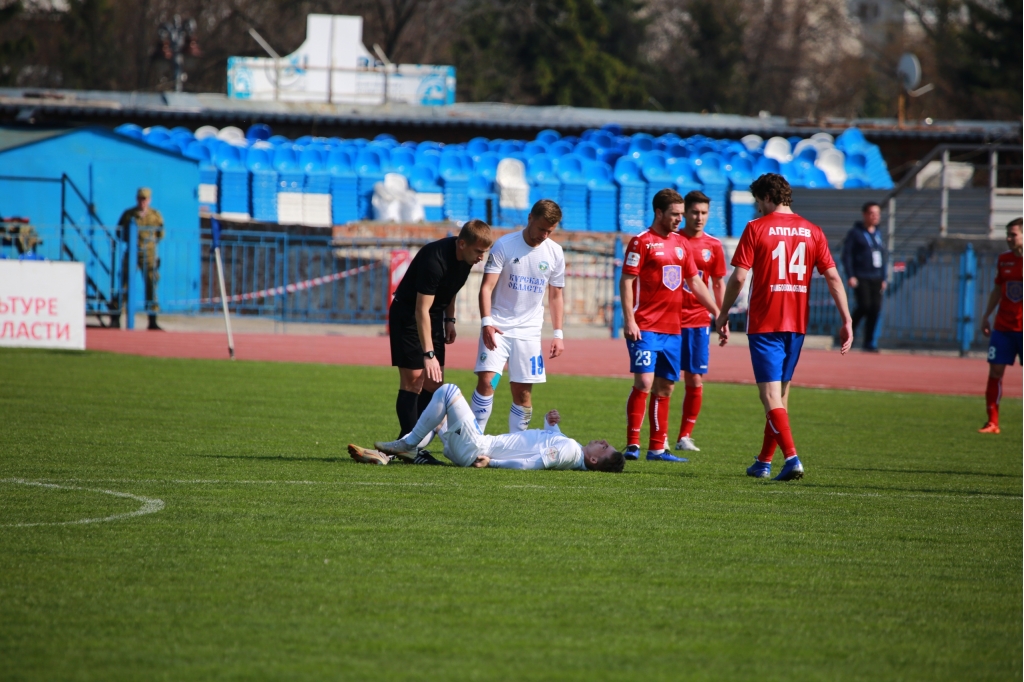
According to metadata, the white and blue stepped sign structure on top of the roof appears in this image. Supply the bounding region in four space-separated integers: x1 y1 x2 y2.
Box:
234 14 455 105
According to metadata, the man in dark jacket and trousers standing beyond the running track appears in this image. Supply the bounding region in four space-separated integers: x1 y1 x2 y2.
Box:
843 202 888 352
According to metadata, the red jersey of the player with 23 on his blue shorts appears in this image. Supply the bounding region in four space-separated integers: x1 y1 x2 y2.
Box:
623 229 697 334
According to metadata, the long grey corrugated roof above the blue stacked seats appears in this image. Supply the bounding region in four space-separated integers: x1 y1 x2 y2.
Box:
0 88 1021 142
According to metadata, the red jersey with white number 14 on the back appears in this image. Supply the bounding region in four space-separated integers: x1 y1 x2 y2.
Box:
732 212 836 334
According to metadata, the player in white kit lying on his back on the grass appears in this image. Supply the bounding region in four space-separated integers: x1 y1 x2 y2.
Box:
348 384 625 472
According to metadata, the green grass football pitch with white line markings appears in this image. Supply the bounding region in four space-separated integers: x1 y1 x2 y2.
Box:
0 348 1022 682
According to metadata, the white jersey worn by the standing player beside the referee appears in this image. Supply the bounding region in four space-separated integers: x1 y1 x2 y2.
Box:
483 231 565 339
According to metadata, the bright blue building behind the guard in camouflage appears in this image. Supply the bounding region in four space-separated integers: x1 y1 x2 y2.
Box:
0 127 201 313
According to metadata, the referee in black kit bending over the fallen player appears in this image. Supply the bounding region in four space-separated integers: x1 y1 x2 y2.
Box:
388 220 494 464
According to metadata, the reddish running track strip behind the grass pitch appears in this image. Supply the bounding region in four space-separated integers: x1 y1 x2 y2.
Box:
86 328 1024 398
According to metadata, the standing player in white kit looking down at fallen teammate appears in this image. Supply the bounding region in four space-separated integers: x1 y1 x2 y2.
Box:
471 199 565 433
